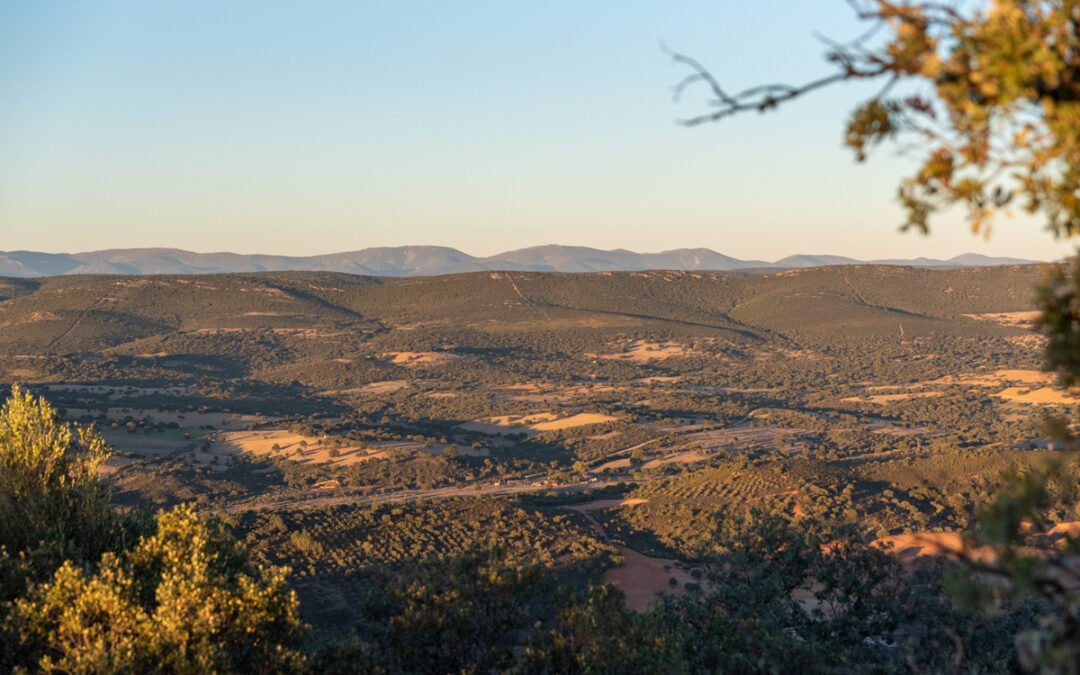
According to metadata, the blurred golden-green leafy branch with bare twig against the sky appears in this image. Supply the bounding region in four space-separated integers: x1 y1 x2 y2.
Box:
672 0 1080 237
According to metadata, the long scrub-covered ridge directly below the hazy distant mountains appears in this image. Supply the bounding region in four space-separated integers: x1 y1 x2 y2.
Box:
0 266 1039 354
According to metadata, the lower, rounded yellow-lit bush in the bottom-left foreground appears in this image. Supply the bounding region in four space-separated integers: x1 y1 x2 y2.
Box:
13 505 305 673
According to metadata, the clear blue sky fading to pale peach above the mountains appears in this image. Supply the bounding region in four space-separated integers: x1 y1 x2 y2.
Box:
0 0 1071 259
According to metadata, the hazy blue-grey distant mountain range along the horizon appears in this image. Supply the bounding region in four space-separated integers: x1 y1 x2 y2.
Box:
0 245 1037 276
